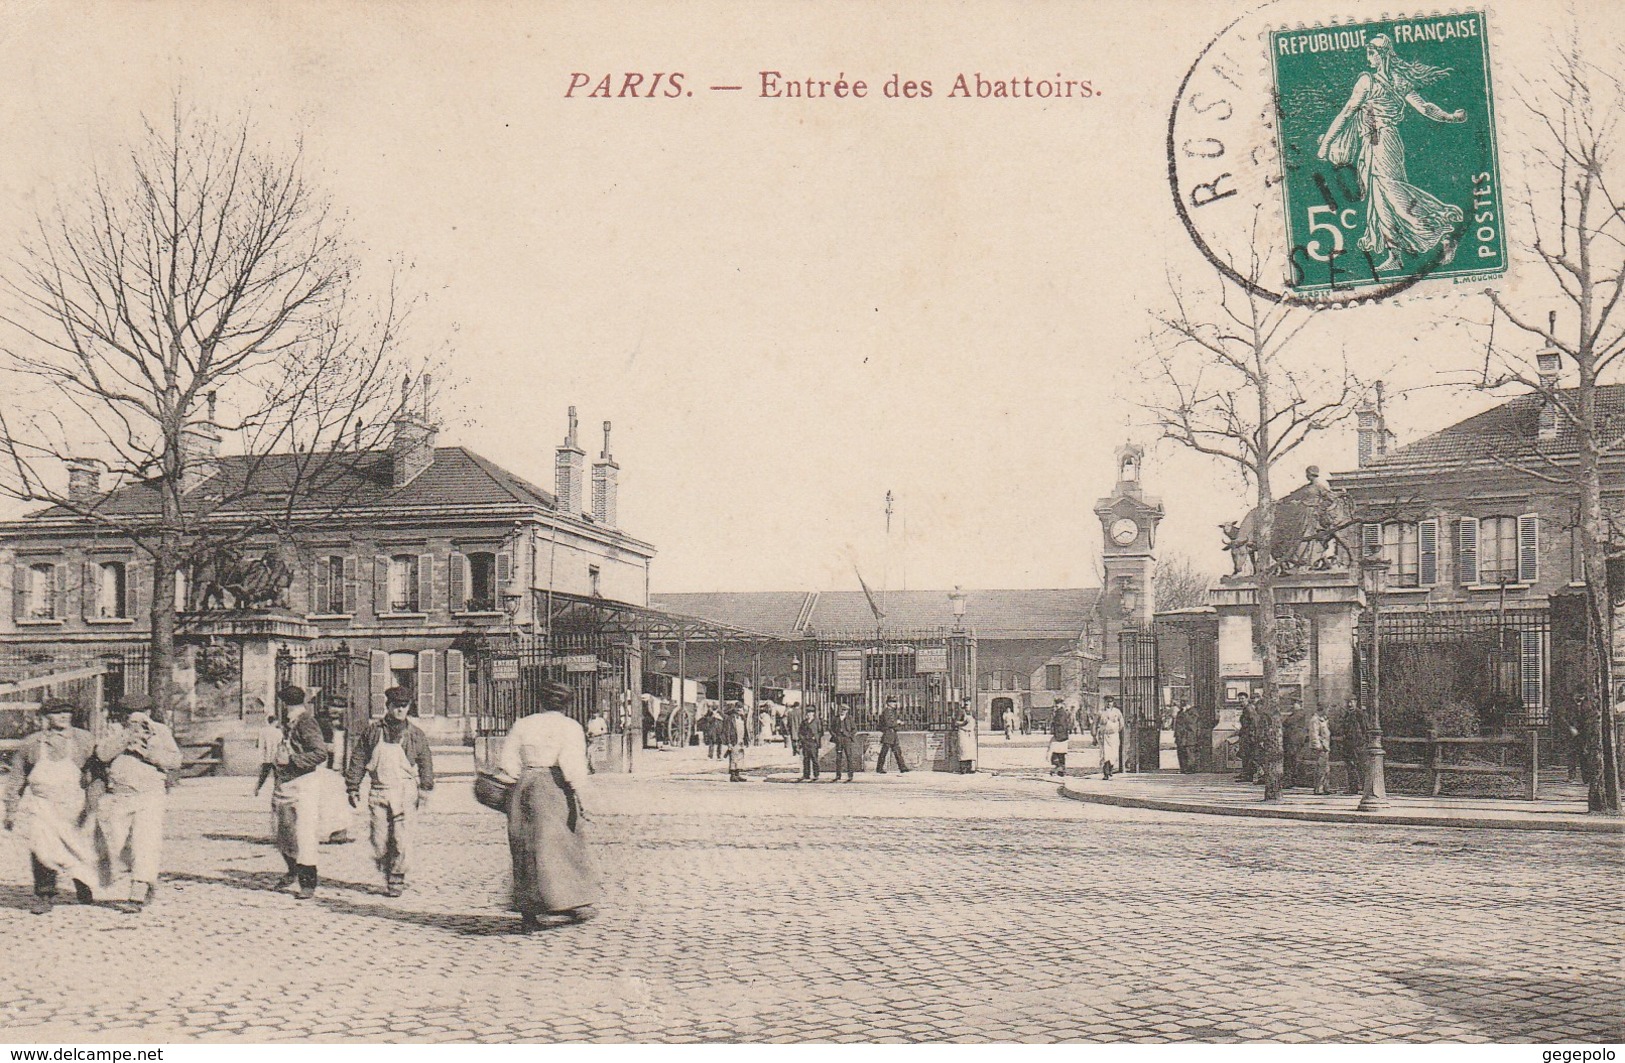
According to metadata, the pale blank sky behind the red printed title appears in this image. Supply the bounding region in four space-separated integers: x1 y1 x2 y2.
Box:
0 0 1625 592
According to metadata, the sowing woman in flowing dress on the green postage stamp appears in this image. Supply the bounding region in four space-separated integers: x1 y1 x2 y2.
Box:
1316 34 1467 270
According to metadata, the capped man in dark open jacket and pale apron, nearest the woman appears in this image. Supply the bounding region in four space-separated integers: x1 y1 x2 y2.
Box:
345 686 434 897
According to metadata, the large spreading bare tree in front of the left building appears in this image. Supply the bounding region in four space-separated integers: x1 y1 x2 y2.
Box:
0 101 425 715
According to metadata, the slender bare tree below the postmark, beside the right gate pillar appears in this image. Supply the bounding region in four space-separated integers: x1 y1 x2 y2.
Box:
1141 254 1360 801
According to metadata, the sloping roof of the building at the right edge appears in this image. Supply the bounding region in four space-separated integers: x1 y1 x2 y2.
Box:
1341 384 1625 476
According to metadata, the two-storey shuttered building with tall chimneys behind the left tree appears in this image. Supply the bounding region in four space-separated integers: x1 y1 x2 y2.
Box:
0 394 655 741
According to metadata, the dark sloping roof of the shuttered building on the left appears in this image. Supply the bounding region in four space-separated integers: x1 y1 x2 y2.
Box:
29 447 557 518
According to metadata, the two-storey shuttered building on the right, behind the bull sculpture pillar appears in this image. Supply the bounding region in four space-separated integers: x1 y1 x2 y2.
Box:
1333 378 1625 737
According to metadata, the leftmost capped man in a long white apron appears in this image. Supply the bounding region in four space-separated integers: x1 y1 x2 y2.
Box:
5 701 96 915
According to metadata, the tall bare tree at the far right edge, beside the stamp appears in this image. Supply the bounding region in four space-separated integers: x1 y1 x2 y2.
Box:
1477 33 1625 813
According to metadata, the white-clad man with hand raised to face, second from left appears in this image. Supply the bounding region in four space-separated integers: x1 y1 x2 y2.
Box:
96 694 182 912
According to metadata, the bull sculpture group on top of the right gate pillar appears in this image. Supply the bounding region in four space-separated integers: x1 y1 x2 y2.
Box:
1219 465 1355 577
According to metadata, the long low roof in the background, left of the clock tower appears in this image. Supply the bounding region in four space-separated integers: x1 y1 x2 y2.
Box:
650 587 1100 639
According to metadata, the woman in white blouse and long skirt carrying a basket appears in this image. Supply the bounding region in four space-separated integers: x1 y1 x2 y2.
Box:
499 681 598 930
